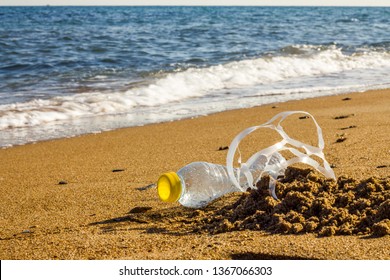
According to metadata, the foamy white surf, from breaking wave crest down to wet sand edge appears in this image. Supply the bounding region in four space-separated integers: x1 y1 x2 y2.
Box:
0 45 390 146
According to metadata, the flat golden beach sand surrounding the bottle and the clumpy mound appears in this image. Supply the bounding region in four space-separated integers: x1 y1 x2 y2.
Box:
0 90 390 259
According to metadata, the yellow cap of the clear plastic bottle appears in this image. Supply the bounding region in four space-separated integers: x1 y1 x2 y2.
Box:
157 172 182 202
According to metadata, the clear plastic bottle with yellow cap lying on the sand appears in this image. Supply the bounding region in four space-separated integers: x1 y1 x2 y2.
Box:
157 153 285 208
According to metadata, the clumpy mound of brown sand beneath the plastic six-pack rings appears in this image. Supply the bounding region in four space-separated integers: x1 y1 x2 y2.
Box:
202 167 390 236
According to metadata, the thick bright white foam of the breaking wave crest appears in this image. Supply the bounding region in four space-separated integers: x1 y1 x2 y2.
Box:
0 46 390 130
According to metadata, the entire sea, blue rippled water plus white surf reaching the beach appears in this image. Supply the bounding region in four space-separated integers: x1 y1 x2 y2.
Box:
0 7 390 147
